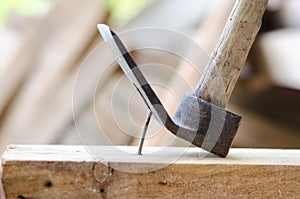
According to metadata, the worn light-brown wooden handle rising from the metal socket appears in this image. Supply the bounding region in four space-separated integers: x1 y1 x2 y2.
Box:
194 0 268 108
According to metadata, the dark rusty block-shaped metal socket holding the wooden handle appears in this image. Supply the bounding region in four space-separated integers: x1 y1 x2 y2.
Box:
173 95 241 157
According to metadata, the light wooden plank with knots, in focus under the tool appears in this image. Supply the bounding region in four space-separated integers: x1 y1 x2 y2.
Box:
2 145 300 198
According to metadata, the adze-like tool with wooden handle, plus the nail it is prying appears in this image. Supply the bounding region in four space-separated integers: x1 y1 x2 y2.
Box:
97 0 268 157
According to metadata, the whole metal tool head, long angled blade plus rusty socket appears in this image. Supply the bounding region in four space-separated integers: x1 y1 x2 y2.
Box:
98 24 241 157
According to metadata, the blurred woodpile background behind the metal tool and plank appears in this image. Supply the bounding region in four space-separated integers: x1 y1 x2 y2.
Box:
0 0 300 151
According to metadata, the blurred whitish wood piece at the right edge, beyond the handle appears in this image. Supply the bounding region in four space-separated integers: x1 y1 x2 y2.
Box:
258 28 300 90
